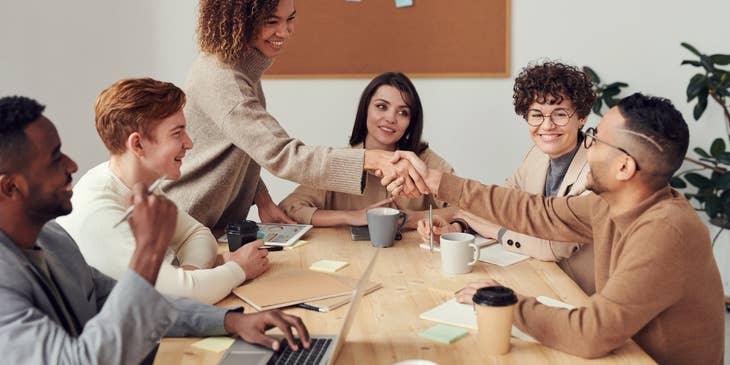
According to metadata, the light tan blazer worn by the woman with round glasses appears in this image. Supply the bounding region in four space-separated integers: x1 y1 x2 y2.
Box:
502 146 596 295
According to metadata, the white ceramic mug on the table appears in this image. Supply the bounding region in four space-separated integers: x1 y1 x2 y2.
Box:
439 232 479 274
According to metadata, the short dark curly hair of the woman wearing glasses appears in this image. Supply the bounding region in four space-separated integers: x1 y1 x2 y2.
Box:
512 61 596 119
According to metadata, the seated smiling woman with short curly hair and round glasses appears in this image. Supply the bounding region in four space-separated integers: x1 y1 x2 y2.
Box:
418 62 596 295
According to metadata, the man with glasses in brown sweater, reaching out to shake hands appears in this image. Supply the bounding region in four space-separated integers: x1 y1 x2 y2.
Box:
389 94 725 365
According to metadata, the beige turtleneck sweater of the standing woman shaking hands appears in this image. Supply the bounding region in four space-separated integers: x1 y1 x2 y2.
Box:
165 48 364 228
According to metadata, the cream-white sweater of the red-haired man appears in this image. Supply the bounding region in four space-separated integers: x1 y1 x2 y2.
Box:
57 162 246 304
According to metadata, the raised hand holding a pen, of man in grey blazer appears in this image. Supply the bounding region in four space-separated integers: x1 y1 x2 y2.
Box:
129 183 177 285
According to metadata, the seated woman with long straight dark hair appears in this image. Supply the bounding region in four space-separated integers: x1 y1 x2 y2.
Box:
279 72 454 228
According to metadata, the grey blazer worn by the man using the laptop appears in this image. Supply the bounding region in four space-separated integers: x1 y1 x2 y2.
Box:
0 222 235 364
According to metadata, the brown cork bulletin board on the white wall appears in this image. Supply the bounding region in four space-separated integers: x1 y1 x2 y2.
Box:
266 0 510 78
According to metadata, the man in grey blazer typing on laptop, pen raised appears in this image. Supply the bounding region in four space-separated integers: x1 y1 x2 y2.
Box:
0 97 309 364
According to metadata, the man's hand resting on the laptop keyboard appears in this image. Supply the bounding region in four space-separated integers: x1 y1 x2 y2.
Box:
224 310 309 351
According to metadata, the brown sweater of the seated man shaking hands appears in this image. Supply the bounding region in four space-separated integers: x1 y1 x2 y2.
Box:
438 174 725 365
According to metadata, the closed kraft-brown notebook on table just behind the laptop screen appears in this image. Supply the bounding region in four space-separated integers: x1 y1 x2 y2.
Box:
233 270 354 311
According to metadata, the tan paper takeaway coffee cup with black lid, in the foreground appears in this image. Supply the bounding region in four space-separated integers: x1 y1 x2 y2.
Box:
472 286 517 355
